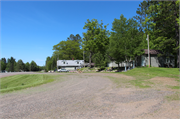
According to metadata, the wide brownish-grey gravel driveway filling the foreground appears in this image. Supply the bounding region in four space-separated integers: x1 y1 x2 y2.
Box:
0 73 180 119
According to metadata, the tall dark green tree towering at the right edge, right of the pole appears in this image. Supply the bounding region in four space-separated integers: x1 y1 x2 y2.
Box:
145 1 180 67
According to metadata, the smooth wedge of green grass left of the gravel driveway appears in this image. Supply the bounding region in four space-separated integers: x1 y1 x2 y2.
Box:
0 74 56 93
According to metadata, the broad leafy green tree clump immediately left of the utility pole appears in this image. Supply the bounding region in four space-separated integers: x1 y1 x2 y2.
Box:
108 15 144 67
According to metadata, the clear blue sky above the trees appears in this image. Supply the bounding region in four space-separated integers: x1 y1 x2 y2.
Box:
0 1 141 66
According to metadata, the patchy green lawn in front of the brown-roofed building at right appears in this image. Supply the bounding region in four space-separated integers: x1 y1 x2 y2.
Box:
111 67 180 89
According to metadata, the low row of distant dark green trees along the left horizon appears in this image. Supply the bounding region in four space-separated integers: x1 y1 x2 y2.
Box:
0 57 45 72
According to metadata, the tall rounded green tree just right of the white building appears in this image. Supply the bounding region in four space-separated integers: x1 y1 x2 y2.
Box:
83 19 109 67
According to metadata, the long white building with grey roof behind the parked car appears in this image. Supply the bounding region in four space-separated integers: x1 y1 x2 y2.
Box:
57 60 84 70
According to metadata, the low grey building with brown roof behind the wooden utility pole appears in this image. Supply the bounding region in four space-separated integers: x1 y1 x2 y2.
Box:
135 49 175 67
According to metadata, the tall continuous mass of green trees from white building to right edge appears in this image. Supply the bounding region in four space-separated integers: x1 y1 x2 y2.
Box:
46 0 180 70
